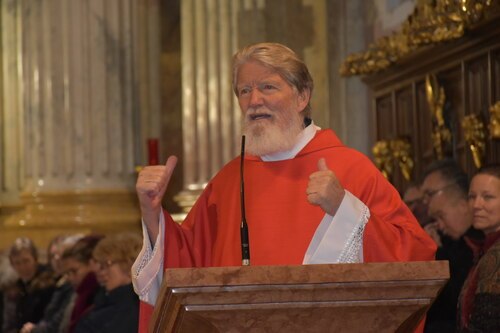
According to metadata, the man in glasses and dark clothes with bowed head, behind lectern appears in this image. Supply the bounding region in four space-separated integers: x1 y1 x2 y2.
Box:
422 160 481 333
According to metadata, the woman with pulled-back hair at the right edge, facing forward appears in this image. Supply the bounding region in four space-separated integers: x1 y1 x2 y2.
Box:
458 165 500 332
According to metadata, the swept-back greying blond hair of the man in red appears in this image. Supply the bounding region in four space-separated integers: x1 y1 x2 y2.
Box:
233 43 314 117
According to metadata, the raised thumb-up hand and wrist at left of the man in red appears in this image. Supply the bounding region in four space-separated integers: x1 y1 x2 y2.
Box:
135 156 177 244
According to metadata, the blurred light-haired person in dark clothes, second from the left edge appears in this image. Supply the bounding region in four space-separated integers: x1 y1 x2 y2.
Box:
9 237 55 330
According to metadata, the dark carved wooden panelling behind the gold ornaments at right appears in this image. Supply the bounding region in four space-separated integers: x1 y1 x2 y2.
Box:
364 18 500 191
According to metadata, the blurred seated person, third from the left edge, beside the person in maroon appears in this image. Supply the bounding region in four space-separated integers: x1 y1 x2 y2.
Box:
20 235 83 333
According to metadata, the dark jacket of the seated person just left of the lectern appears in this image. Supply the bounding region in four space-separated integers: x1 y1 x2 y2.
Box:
75 284 139 333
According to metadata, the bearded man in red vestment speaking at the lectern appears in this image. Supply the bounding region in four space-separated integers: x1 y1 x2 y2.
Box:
133 43 435 328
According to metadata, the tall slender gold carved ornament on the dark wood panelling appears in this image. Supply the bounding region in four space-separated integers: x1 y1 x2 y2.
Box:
425 74 451 160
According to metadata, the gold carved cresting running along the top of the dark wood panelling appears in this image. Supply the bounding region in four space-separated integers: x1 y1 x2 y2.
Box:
340 0 500 76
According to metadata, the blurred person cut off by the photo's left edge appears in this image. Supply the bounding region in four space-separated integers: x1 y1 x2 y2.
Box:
0 249 19 333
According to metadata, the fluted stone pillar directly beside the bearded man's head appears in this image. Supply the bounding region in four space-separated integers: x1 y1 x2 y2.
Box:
176 0 241 211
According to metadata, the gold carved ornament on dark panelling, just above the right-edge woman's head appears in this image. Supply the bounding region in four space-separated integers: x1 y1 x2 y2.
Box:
462 114 486 168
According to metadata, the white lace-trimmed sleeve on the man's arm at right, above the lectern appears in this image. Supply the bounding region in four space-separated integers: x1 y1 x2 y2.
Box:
303 191 370 264
